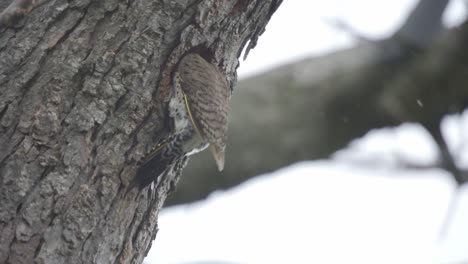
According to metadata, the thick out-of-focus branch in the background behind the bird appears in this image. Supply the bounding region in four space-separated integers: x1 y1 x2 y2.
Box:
165 0 468 205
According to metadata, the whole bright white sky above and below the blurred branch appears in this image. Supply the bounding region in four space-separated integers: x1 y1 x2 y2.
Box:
145 0 468 264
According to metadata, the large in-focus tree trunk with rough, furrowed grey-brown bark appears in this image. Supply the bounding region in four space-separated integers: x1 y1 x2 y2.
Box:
0 0 281 263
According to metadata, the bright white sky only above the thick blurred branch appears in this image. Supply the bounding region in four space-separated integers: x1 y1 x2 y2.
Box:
238 0 466 78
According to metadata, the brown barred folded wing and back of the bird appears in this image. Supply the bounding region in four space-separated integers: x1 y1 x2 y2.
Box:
178 53 230 170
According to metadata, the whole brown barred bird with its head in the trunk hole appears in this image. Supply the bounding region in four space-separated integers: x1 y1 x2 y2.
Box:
132 53 231 190
